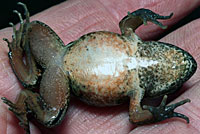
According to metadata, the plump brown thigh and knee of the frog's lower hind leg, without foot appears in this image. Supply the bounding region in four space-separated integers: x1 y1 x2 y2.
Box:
33 65 70 127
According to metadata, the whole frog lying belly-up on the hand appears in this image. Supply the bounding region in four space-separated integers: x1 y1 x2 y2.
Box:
2 2 197 134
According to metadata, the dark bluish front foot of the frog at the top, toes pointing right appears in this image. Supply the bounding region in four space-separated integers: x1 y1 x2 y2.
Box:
128 8 173 29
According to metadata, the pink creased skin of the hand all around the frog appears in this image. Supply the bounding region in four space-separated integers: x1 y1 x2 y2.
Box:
0 0 200 134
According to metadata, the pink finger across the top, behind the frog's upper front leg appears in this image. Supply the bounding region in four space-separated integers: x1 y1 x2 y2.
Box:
26 0 200 44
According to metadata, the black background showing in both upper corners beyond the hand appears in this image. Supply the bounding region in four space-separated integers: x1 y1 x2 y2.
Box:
0 0 200 30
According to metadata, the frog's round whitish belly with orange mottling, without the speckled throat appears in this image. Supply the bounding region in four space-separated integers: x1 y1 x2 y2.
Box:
64 32 139 106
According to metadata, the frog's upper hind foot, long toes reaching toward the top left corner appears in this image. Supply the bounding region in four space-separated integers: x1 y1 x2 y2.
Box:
4 2 40 87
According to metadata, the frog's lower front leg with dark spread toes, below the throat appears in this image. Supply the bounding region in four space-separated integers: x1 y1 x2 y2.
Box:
129 89 190 124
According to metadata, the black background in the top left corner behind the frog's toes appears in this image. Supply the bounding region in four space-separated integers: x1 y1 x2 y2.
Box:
0 0 66 29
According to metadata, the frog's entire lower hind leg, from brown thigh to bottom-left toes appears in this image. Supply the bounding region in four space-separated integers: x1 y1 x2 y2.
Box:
2 66 70 134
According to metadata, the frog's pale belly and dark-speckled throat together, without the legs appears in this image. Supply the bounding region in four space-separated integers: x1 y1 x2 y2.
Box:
63 31 195 106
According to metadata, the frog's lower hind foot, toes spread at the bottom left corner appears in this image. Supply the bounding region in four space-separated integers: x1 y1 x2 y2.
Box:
1 97 30 134
